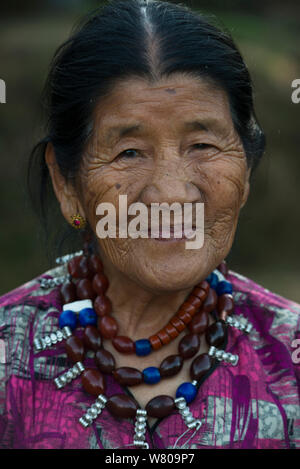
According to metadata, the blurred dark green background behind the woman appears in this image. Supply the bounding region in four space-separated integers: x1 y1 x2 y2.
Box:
0 0 300 302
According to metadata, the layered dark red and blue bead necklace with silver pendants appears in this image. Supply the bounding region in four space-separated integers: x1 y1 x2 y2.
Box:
34 249 251 449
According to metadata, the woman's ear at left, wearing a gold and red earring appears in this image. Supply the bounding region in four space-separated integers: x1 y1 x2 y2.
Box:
45 142 85 223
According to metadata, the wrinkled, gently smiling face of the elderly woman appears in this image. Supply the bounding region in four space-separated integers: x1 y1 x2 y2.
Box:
55 74 249 291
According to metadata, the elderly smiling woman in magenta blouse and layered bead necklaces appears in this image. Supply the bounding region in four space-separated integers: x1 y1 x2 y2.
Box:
0 0 300 449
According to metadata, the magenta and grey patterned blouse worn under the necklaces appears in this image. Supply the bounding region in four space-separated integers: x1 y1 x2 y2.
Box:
0 266 300 449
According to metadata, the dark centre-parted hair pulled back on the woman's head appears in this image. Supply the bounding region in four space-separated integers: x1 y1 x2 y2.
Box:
28 0 265 256
